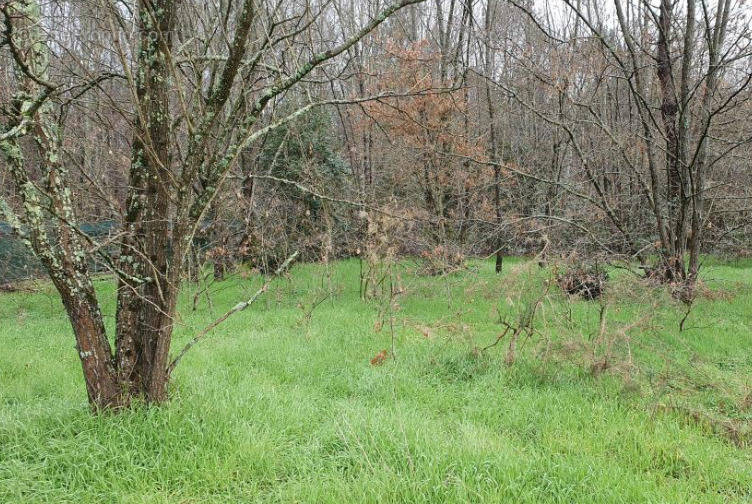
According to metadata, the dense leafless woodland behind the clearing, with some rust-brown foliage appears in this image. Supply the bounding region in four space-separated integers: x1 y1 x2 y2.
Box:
0 0 752 282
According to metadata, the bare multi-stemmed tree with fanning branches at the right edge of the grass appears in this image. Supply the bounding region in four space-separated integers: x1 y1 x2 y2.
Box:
488 0 752 286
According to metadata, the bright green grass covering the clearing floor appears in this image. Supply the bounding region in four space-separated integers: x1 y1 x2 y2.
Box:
0 260 752 504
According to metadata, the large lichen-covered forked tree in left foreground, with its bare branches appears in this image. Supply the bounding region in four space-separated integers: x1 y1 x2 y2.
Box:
0 0 420 409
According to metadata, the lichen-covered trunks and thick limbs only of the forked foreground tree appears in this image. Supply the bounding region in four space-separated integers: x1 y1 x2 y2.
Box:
0 0 423 410
